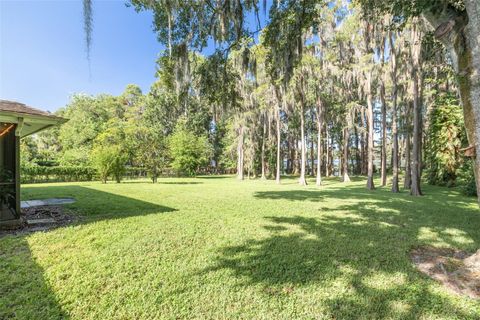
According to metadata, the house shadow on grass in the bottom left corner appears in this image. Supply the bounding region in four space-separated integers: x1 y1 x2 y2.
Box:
0 237 69 319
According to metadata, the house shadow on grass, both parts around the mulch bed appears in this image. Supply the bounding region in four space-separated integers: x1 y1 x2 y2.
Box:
0 185 175 319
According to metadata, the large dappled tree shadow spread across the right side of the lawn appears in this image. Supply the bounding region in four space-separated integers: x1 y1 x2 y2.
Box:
201 186 480 319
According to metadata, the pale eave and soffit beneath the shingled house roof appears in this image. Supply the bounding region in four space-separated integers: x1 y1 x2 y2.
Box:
0 110 68 138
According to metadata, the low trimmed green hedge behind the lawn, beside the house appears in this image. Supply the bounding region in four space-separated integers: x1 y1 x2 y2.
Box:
20 164 97 183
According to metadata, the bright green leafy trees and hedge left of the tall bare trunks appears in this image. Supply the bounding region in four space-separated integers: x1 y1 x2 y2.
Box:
21 85 219 183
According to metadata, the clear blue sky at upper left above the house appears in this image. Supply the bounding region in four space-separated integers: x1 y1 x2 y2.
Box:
0 0 164 112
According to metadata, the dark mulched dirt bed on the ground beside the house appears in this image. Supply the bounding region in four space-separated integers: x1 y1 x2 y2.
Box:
0 205 79 237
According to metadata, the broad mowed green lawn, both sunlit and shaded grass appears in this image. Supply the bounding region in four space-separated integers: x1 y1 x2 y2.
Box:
0 176 480 319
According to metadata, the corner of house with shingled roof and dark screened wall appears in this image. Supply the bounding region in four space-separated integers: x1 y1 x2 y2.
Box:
0 100 67 227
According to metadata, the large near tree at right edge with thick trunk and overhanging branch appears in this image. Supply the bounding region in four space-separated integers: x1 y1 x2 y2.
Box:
357 0 480 201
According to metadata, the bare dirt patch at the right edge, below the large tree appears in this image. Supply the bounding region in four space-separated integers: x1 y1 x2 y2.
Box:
411 246 480 299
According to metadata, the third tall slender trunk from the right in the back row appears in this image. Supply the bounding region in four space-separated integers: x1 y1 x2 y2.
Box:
390 33 400 193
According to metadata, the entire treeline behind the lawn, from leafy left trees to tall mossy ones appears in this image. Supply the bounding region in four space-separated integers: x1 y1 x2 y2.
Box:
23 2 476 195
